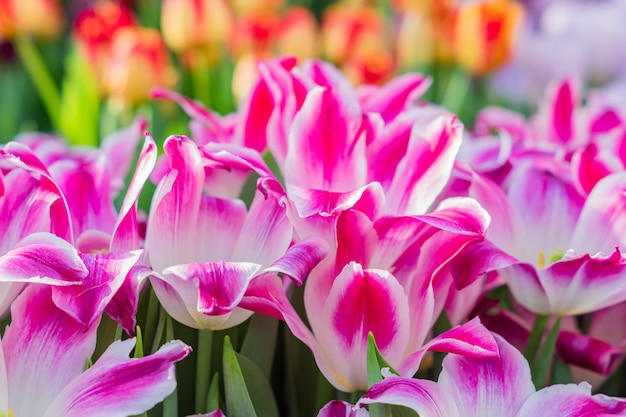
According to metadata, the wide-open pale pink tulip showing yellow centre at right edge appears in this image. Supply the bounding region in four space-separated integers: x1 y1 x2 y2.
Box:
470 164 626 315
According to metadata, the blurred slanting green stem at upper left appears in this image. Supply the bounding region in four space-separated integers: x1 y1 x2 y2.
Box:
14 35 61 129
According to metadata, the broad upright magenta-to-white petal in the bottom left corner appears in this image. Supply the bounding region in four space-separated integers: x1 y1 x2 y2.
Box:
2 285 98 416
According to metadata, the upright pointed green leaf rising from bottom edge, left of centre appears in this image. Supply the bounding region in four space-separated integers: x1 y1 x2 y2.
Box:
222 336 257 417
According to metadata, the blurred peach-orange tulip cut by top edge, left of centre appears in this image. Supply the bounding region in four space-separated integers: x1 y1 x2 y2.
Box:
161 0 234 52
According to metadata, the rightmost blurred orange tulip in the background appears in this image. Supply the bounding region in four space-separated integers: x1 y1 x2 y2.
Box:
454 0 523 75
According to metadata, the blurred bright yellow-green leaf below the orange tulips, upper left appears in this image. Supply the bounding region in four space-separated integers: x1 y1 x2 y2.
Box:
59 48 100 146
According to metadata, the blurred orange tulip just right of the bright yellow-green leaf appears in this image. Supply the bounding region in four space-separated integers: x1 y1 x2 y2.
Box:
104 27 176 104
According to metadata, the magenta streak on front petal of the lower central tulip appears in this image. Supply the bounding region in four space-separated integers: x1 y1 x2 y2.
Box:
333 268 398 350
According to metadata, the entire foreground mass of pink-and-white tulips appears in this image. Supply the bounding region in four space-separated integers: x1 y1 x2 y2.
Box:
0 54 626 416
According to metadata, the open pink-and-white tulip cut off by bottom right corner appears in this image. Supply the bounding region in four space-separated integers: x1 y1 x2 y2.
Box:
354 335 626 417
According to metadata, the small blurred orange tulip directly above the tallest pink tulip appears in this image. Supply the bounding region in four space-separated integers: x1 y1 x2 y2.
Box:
274 7 318 60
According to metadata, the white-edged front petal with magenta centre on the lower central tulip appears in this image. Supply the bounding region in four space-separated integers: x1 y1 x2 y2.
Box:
316 262 410 392
